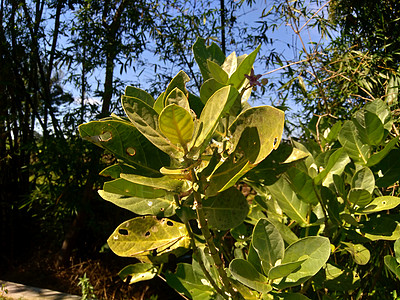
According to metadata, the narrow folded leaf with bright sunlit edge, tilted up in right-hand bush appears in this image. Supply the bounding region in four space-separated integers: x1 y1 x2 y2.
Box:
314 148 350 186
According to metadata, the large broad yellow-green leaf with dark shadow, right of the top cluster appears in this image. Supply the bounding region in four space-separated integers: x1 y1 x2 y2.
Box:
229 106 285 164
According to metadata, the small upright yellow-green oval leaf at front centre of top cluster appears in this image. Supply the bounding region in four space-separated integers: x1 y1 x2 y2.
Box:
159 104 194 148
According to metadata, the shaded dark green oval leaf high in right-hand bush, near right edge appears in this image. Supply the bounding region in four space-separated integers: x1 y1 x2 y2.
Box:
353 109 384 146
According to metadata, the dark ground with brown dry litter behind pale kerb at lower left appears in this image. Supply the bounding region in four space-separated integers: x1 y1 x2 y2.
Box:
0 253 183 300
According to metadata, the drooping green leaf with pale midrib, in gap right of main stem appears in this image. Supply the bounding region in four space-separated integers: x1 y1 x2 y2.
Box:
267 177 309 226
